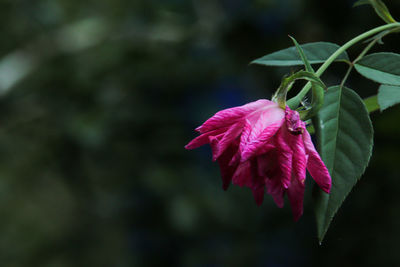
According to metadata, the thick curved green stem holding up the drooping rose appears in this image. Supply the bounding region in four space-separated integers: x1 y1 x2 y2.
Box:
288 23 400 107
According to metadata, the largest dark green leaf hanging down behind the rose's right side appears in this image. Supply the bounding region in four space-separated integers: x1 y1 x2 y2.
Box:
313 86 373 242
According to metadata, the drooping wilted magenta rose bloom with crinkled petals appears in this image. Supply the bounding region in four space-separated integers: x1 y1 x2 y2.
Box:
185 99 331 220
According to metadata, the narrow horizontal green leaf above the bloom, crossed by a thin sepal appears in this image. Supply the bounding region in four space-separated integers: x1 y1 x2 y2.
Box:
250 42 349 66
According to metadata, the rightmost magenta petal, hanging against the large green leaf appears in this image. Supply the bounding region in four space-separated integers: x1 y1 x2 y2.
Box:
302 131 332 193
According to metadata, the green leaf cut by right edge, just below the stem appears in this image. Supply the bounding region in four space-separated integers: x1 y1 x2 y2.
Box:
354 52 400 85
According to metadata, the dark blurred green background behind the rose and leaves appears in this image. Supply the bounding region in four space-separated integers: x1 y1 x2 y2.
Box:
0 0 400 267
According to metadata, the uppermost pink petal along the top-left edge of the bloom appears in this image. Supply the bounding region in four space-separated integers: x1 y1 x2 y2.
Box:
196 99 275 133
